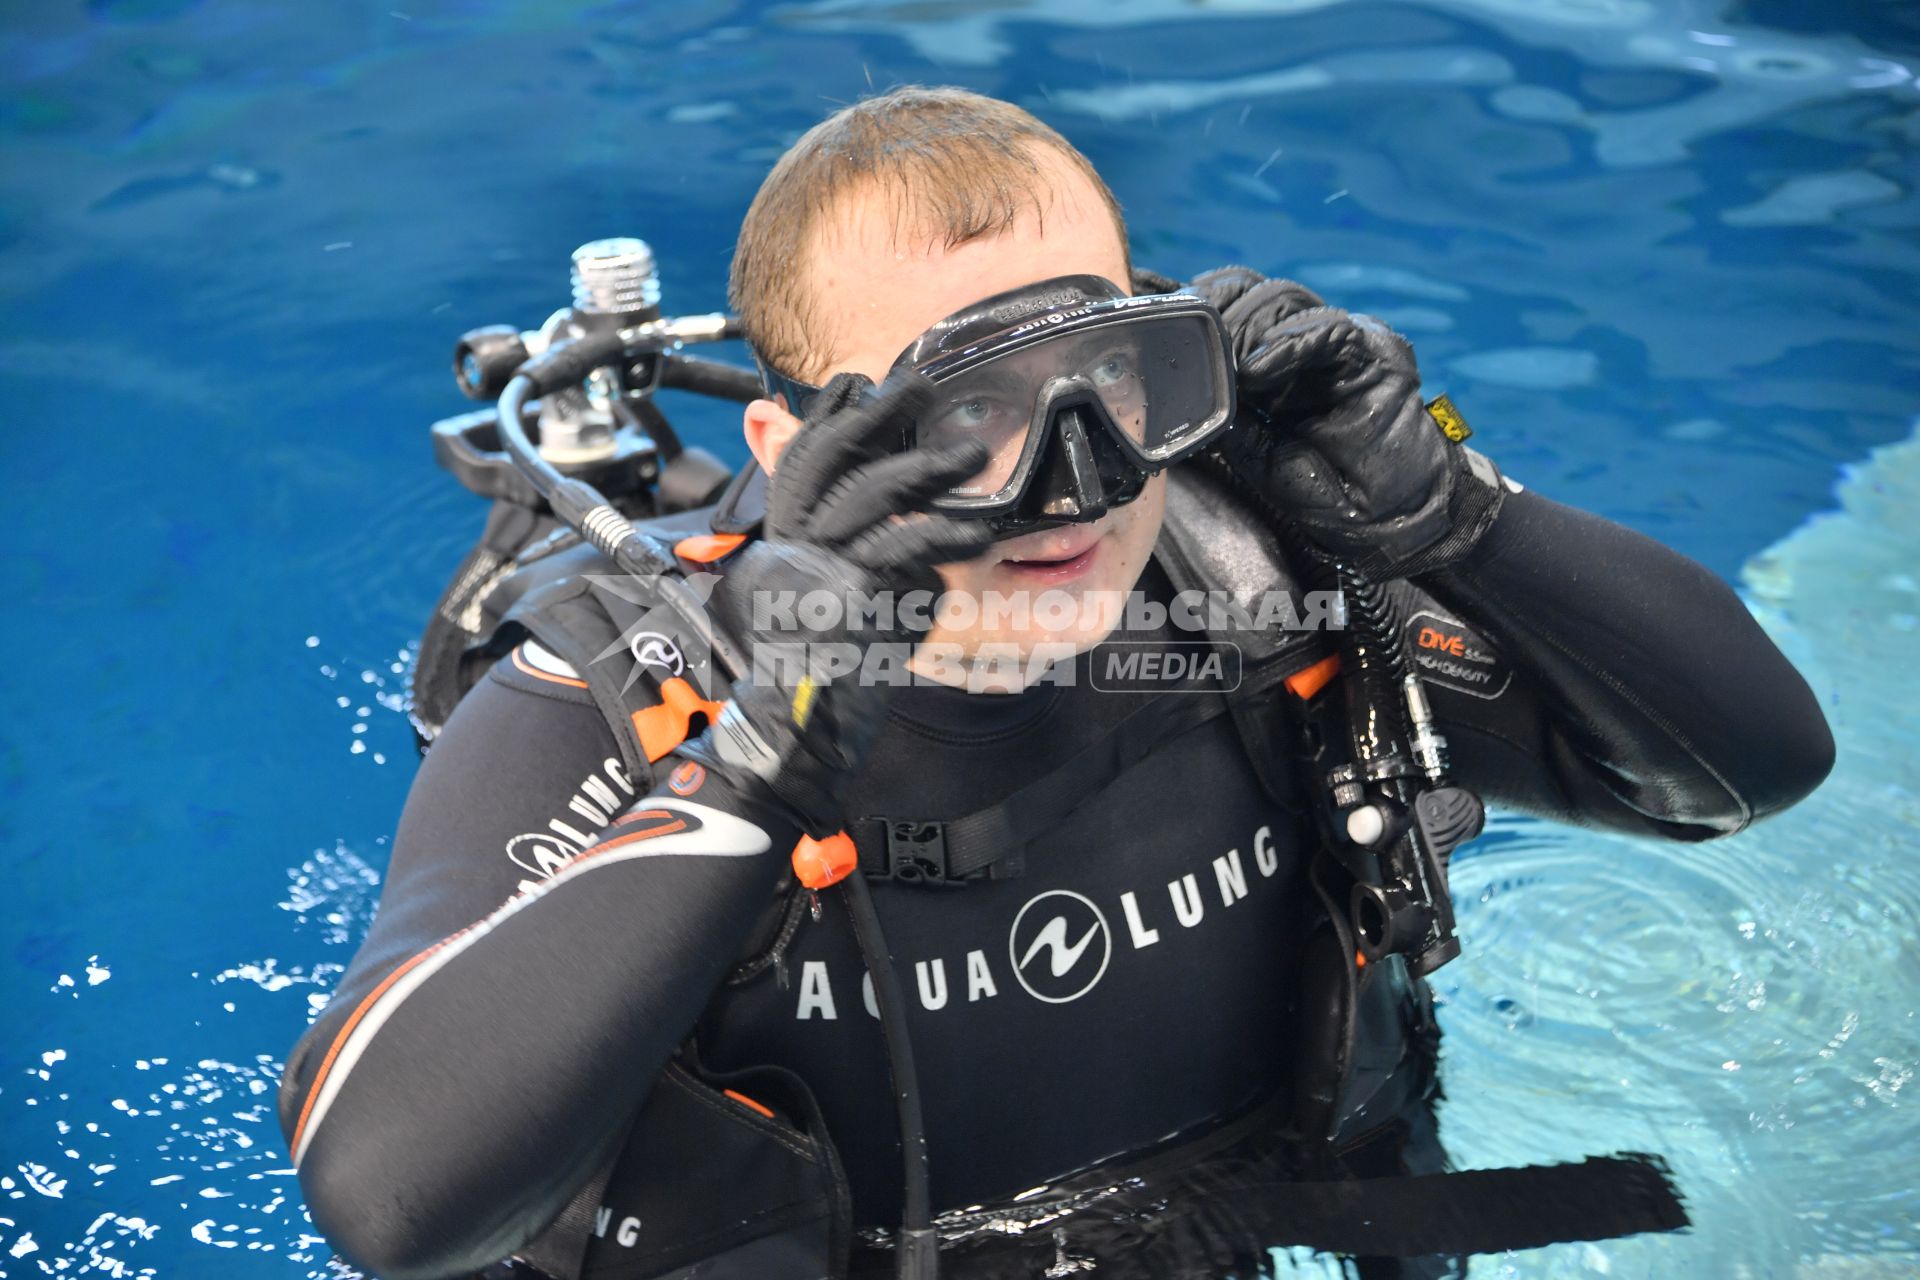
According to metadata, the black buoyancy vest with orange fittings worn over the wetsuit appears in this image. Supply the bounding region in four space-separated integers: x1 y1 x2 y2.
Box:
413 466 1678 1280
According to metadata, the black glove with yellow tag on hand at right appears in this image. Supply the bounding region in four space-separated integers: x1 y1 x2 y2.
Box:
1190 267 1505 581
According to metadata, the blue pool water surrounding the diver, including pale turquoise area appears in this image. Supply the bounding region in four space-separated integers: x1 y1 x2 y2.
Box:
0 0 1920 1280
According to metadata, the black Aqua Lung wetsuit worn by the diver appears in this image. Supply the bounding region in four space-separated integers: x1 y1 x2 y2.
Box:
280 493 1832 1276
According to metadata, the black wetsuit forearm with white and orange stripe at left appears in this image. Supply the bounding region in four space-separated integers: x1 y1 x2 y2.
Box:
280 762 797 1280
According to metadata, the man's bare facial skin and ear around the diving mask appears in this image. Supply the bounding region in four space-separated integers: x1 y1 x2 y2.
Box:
747 154 1165 687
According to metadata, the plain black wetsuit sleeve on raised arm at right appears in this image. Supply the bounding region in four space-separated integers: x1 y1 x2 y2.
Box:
1409 491 1834 841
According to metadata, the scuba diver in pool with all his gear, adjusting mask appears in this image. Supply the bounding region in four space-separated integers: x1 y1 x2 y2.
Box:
280 86 1834 1280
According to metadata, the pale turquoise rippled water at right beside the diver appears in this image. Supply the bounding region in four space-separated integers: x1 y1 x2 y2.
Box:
1436 427 1920 1276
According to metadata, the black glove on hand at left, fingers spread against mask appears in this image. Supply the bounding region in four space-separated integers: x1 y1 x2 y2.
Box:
710 374 993 837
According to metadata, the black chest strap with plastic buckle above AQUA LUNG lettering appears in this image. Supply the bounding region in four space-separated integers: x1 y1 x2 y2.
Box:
847 689 1227 883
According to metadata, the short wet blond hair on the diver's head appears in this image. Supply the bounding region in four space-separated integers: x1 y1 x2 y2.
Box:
728 84 1133 382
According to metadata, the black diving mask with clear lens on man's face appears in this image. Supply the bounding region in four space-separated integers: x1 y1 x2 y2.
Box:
760 276 1235 535
